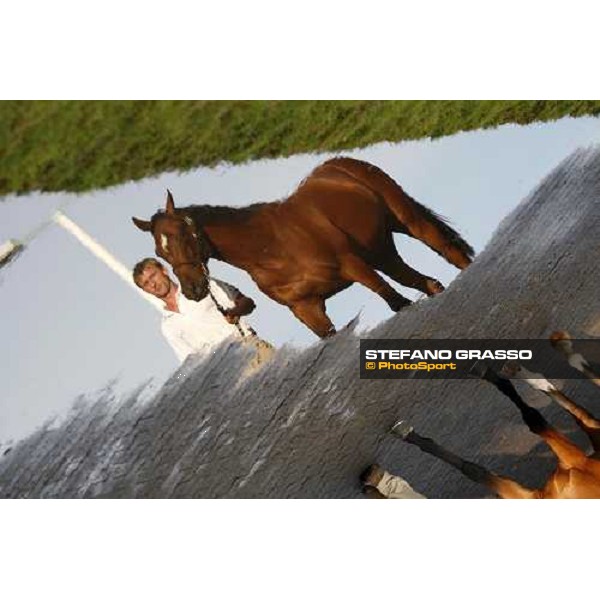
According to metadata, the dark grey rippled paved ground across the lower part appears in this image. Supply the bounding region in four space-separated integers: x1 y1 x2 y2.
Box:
0 150 600 498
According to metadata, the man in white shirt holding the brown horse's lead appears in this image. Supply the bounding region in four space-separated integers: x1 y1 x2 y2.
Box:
133 258 273 366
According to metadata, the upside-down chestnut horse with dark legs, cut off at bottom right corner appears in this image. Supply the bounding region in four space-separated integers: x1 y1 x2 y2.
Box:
392 332 600 498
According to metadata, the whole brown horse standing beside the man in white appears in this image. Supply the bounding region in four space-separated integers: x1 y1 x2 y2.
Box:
133 157 473 337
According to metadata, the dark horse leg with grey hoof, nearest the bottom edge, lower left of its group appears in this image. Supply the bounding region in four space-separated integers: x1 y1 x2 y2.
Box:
392 421 536 499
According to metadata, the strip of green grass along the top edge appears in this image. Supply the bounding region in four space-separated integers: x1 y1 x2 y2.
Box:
0 100 600 195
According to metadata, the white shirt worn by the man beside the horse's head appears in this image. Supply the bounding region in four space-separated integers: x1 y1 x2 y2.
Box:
161 279 252 362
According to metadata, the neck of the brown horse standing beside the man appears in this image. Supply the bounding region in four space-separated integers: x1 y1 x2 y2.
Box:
185 205 271 268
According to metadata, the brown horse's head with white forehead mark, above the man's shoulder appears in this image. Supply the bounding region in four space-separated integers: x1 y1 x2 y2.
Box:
132 190 210 301
